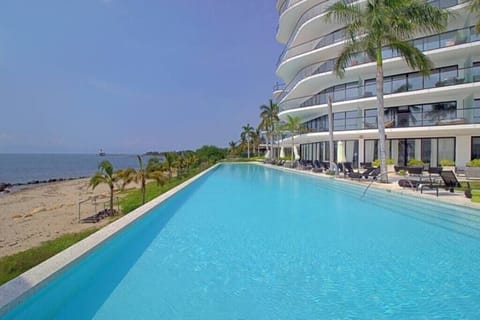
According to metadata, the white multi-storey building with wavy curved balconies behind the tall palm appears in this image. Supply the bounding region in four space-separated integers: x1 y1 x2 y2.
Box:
274 0 480 166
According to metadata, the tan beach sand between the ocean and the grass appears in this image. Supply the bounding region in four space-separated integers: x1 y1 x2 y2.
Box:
0 179 131 257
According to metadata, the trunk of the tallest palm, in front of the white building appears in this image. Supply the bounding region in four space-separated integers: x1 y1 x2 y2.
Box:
376 51 388 182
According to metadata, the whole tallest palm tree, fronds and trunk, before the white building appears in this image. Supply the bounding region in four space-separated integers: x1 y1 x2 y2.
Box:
327 0 448 182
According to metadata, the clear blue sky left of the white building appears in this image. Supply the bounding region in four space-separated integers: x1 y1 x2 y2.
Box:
0 0 282 153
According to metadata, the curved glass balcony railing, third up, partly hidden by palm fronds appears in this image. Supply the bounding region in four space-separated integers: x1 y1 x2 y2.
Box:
279 27 480 105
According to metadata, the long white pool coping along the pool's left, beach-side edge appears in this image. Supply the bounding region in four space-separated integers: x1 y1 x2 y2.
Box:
0 164 220 317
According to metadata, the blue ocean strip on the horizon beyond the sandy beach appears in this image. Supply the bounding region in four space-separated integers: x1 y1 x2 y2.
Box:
0 153 156 184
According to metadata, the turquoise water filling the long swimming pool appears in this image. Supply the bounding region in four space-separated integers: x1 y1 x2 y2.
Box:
3 164 480 319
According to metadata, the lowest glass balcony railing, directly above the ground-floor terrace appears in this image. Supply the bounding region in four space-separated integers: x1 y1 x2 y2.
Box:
307 107 480 132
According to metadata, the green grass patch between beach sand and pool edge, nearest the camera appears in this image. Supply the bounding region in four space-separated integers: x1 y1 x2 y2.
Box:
0 228 98 284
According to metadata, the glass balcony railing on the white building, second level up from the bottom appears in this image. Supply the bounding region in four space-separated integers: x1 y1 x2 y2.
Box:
280 64 480 111
